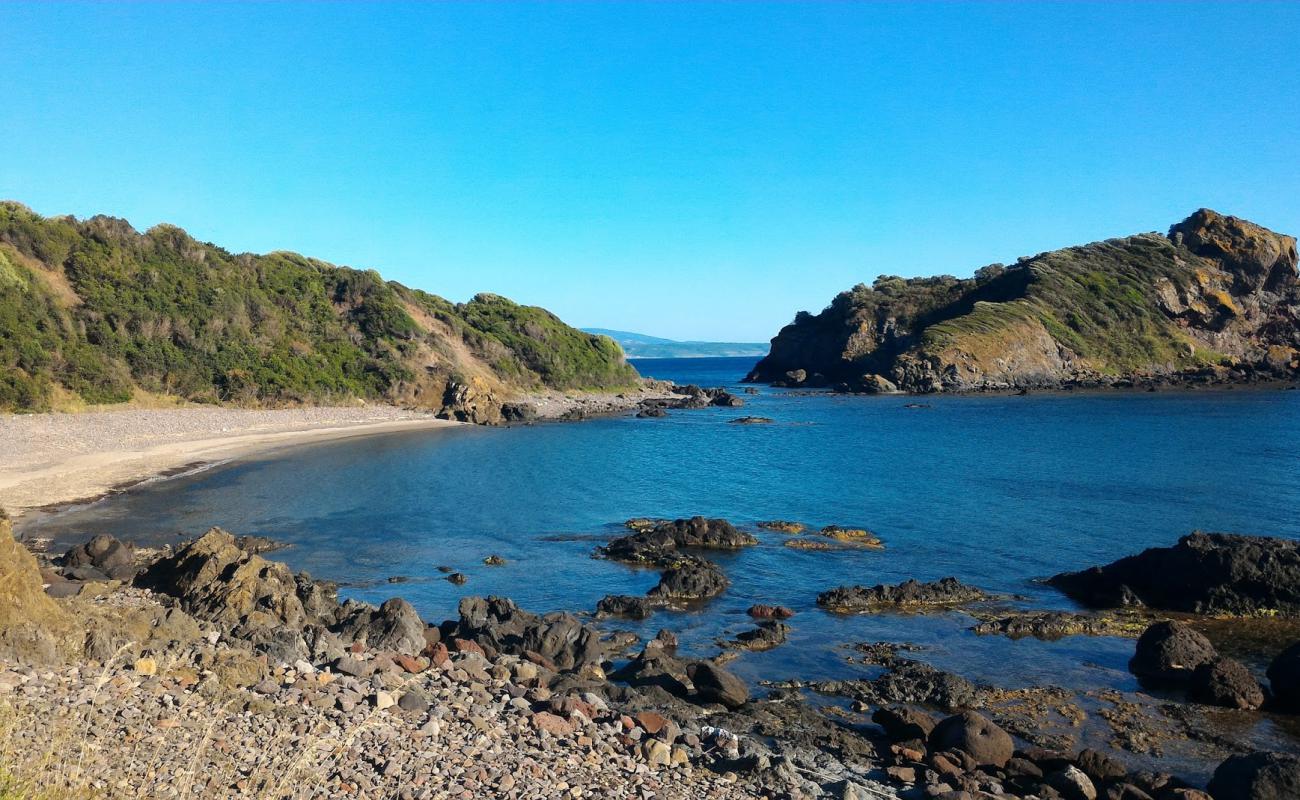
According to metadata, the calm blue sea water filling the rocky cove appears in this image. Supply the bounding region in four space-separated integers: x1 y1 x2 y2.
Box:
23 359 1300 780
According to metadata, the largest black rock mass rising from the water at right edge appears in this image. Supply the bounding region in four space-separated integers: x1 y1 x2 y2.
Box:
1048 533 1300 615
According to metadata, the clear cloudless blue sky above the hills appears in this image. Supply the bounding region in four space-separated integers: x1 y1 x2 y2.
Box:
0 3 1300 341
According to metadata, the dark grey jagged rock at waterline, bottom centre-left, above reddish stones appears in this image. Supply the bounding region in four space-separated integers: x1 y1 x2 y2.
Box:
452 597 605 670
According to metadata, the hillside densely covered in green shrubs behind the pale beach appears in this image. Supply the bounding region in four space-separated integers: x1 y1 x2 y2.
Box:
0 203 637 423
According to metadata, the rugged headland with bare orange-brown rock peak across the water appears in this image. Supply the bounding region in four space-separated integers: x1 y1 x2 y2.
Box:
748 208 1300 392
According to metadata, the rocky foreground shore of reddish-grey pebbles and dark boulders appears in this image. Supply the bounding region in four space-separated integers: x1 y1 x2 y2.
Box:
0 518 1300 800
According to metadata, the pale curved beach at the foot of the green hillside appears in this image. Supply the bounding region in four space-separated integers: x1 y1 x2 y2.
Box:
0 406 463 516
